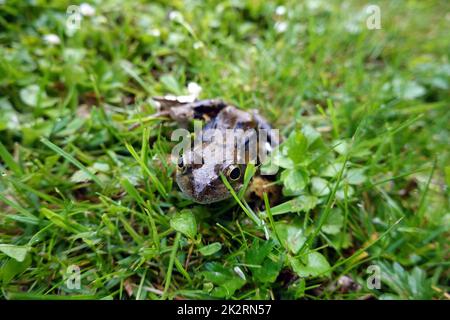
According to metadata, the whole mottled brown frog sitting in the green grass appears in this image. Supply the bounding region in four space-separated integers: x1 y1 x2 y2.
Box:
153 97 279 205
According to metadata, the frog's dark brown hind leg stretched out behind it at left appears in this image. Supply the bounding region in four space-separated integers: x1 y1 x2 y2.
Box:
153 97 227 125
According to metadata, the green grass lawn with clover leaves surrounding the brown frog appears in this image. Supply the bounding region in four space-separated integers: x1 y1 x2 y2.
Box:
0 0 450 299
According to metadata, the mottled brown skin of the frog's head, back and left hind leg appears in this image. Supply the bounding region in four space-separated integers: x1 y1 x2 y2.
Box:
154 98 278 204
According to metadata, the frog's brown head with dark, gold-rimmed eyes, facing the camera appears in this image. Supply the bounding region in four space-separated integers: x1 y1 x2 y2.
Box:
176 151 245 204
